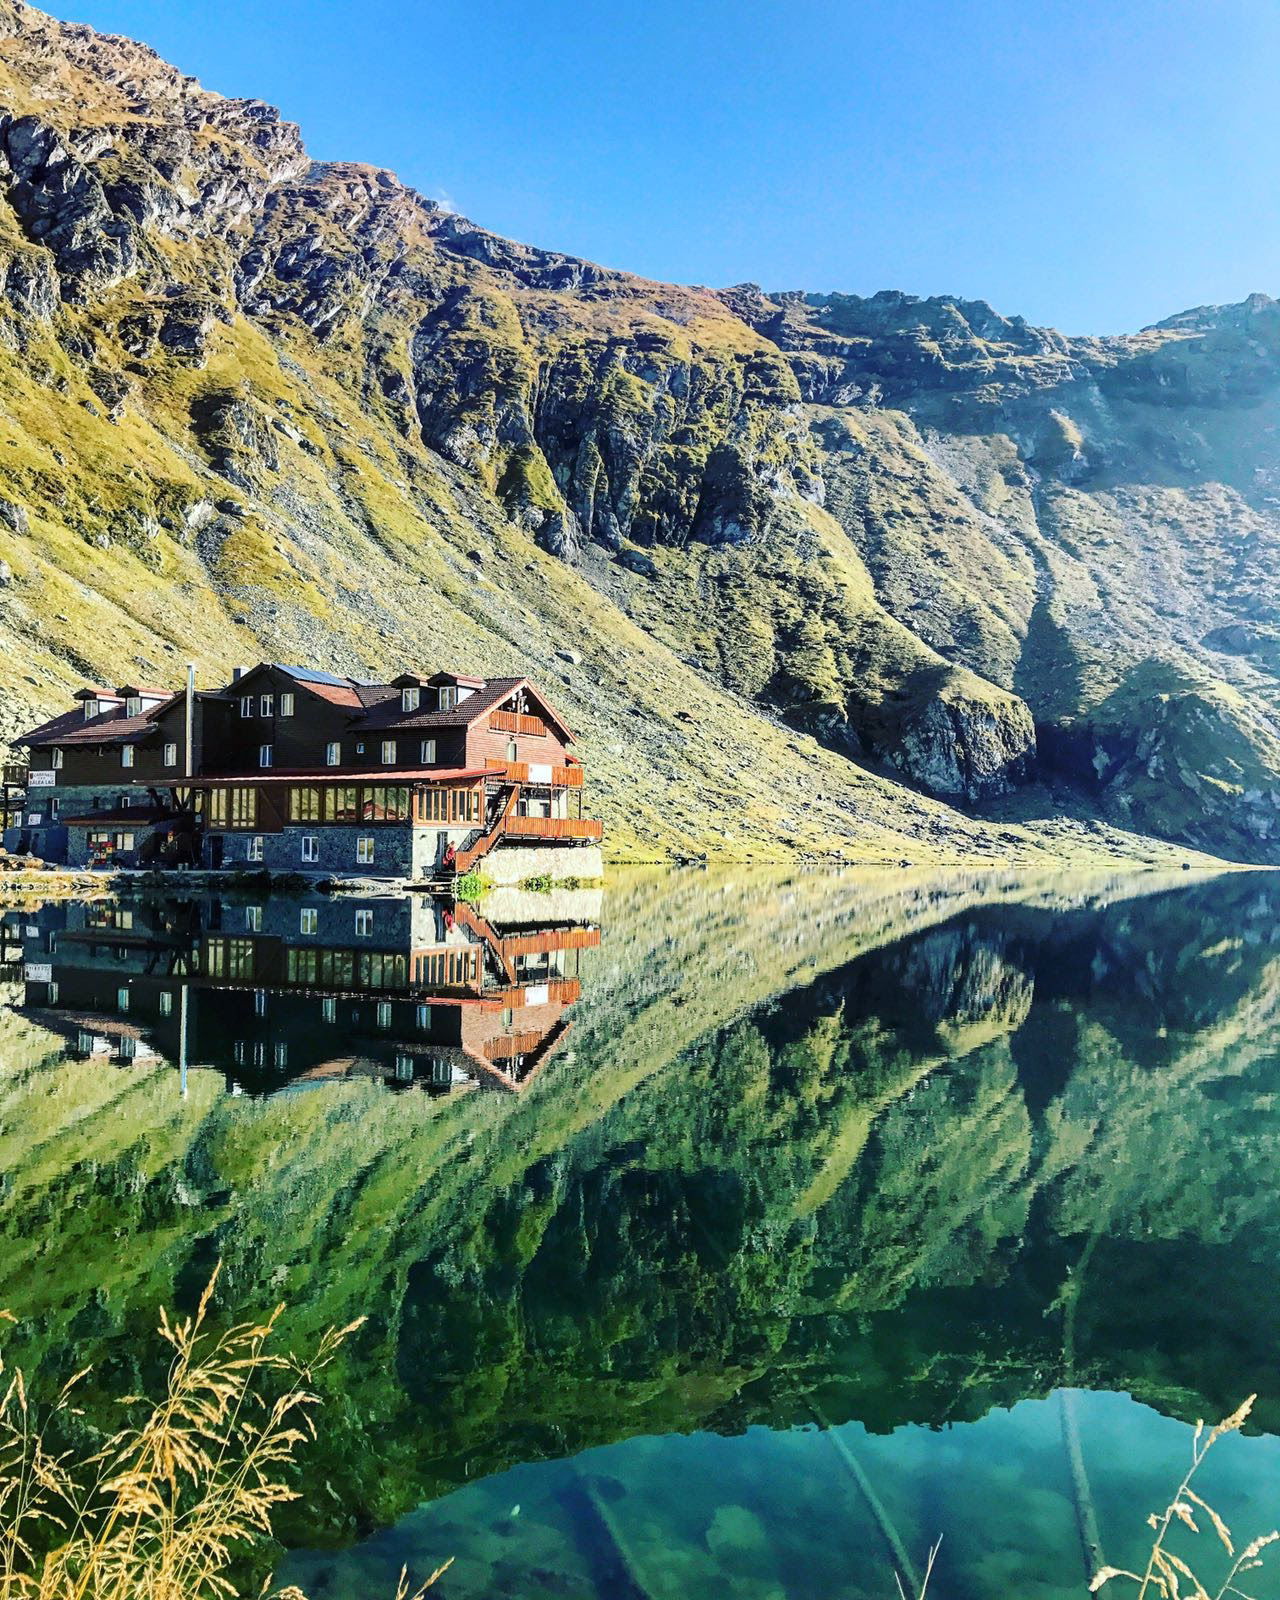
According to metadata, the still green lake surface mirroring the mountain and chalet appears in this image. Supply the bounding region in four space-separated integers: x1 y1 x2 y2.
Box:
0 870 1280 1600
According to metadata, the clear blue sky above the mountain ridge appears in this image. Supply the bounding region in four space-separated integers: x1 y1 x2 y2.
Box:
45 0 1280 333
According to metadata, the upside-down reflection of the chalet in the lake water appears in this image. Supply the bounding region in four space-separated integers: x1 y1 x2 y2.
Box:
0 893 600 1094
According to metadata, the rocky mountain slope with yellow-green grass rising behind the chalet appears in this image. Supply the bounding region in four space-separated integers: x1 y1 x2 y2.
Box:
0 0 1280 859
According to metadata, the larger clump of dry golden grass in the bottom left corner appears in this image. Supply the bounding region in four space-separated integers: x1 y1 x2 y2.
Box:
0 1272 445 1600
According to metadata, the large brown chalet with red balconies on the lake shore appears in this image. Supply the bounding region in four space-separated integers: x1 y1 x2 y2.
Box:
5 662 602 883
